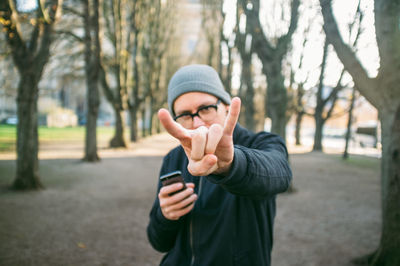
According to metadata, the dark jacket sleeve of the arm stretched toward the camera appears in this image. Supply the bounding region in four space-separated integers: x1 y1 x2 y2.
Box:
208 132 292 199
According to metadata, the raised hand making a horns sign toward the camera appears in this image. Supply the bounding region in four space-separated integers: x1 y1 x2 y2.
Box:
158 97 241 176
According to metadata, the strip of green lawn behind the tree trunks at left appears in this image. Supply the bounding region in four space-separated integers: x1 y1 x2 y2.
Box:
0 125 122 152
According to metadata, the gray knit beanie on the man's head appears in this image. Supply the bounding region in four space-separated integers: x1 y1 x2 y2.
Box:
168 65 231 115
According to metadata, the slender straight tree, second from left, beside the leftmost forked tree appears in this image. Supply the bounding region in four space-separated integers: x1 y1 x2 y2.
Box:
83 0 101 162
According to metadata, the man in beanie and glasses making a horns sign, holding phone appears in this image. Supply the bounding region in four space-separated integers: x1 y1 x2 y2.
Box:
147 65 292 266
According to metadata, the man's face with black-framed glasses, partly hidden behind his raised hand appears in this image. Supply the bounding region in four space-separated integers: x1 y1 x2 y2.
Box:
173 92 229 129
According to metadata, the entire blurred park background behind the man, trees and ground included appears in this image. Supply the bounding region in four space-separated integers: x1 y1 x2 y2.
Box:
0 0 400 266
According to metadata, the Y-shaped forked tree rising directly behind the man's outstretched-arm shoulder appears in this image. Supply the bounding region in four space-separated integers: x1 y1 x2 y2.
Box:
243 0 300 138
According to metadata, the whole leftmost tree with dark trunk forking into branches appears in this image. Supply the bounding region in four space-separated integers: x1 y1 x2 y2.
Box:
0 0 62 190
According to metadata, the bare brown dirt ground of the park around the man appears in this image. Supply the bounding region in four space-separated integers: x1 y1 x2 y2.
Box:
0 135 381 266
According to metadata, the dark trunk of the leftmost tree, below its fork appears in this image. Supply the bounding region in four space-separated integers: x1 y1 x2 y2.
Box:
13 73 43 190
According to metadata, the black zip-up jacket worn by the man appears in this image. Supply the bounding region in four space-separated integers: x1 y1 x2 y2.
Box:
147 125 292 266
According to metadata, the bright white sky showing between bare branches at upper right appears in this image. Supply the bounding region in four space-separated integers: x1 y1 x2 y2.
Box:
224 0 379 88
